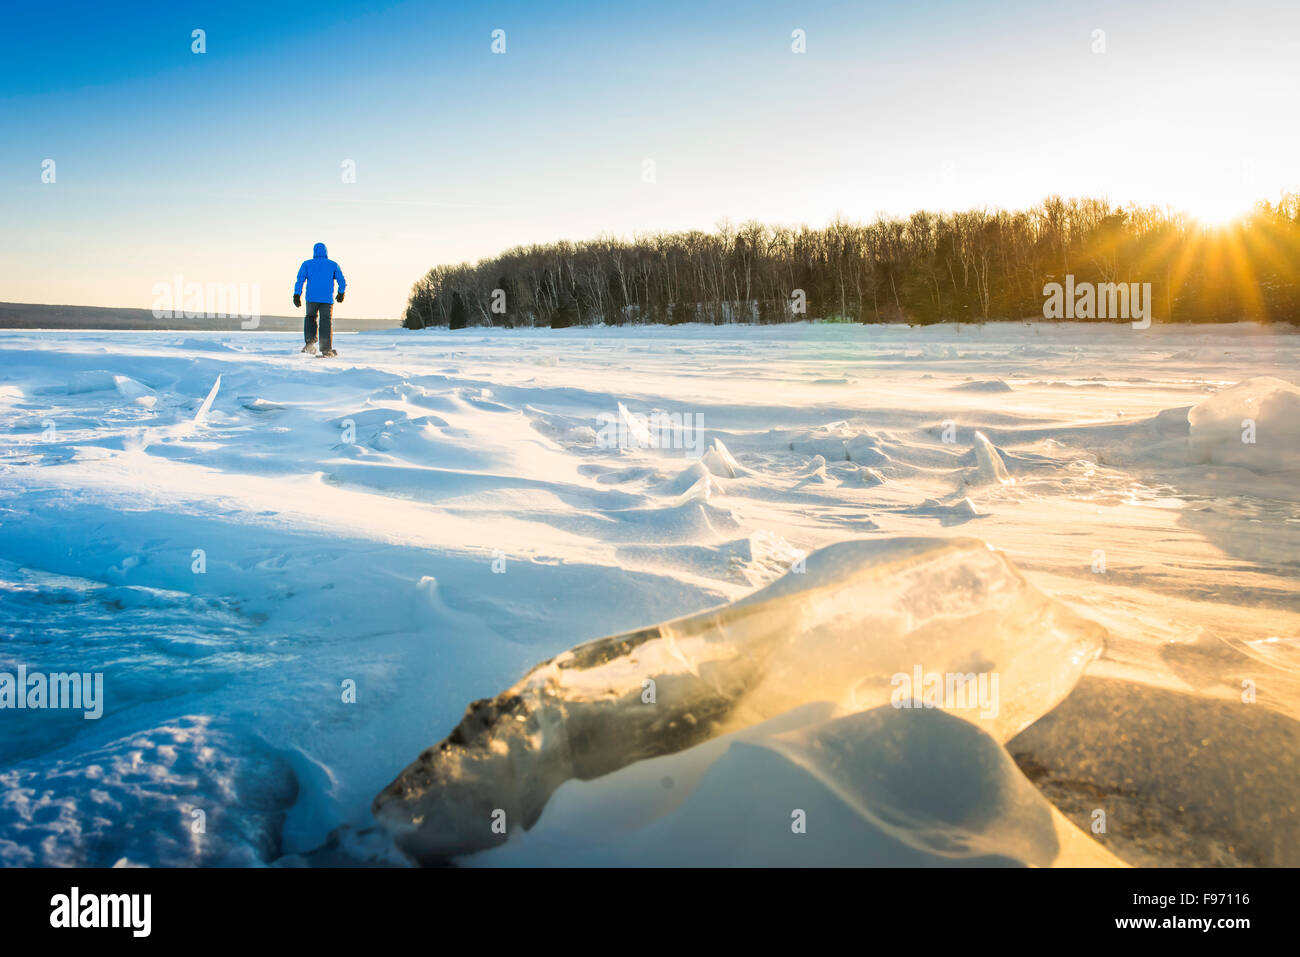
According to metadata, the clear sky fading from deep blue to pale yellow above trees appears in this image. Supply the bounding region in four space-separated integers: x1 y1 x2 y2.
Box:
0 0 1300 317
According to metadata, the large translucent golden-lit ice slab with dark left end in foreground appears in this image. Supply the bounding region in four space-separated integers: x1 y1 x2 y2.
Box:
373 538 1104 862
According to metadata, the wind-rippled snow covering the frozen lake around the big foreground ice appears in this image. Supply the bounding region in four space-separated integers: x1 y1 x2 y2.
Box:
0 324 1300 866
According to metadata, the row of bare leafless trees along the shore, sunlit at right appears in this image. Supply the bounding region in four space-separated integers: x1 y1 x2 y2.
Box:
403 194 1300 329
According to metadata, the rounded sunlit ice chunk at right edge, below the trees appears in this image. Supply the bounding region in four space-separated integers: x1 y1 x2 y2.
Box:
1187 376 1300 472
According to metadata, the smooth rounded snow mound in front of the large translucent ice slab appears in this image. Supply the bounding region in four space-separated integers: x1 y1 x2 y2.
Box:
472 705 1076 867
